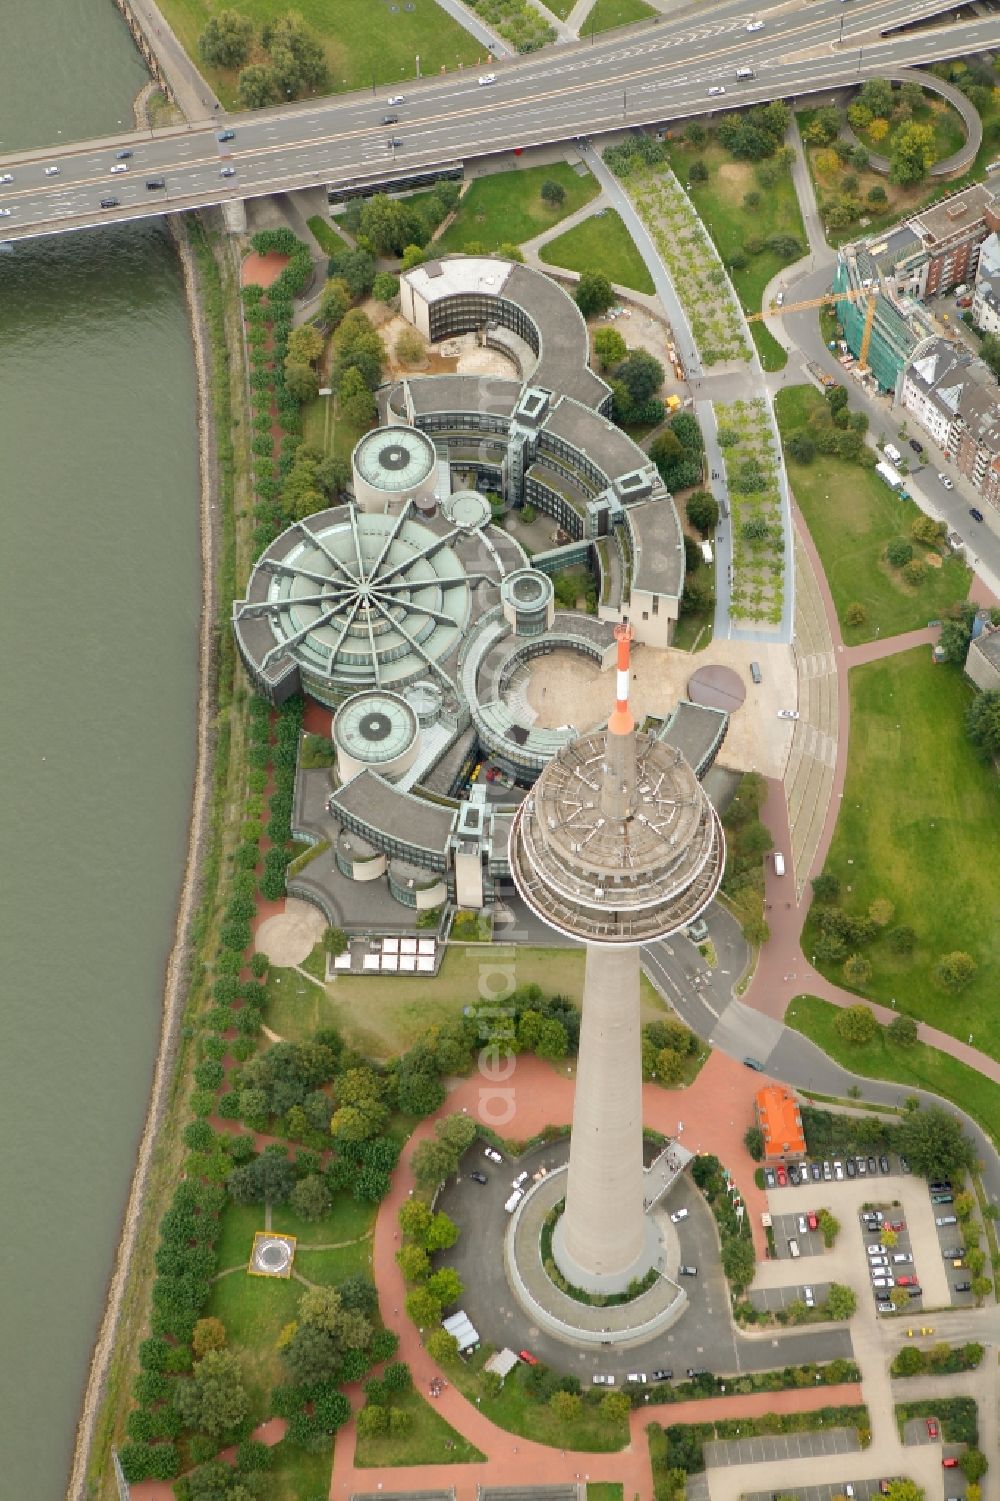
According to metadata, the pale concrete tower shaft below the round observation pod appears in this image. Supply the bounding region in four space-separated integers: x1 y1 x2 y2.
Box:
554 944 644 1286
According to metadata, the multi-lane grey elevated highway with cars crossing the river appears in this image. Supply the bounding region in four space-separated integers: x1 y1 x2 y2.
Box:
0 0 984 240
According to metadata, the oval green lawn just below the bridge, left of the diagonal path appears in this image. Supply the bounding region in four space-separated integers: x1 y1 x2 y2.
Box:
434 162 599 255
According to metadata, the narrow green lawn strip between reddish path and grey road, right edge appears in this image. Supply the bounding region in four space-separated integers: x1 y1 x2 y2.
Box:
785 995 1000 1144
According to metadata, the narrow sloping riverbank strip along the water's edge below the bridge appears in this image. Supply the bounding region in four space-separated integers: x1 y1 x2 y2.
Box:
66 208 222 1501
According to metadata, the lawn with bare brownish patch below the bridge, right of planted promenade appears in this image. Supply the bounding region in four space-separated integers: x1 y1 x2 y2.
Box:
660 135 808 371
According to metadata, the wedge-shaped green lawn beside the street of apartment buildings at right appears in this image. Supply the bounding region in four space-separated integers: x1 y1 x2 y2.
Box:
775 386 970 645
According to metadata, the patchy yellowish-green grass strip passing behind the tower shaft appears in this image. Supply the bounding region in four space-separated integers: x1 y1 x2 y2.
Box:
267 946 678 1050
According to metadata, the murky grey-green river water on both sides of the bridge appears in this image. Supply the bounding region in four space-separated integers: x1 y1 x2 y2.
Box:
0 0 200 1501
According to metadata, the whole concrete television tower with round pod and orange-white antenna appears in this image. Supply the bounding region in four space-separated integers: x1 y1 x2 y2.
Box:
511 624 725 1292
